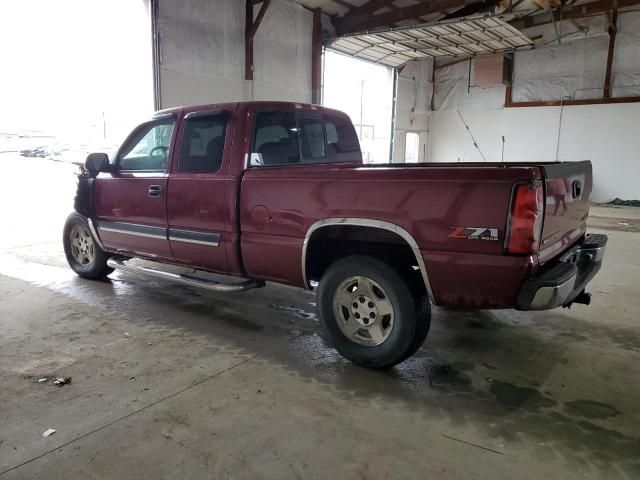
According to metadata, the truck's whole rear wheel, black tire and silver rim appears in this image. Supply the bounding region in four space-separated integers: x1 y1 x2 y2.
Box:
317 256 428 368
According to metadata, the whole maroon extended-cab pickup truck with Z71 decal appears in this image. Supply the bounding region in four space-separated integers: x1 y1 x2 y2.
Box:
64 102 607 367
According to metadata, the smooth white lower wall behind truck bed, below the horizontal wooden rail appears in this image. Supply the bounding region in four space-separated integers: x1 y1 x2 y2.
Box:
430 103 640 202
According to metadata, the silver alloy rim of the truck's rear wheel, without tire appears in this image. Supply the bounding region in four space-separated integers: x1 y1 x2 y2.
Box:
333 276 394 347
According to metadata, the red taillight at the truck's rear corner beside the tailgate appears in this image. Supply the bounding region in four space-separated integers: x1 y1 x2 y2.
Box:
506 182 544 255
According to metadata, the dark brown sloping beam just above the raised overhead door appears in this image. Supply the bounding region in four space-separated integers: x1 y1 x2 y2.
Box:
336 0 476 35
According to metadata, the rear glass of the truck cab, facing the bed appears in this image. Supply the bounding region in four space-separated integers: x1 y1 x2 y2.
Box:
251 110 362 167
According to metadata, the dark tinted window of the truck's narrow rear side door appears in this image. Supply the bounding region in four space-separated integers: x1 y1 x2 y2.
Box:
178 112 228 173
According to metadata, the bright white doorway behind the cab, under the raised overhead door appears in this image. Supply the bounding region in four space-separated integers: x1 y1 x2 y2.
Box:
323 50 393 163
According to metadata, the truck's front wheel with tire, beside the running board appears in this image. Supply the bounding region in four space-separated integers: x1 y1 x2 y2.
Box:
62 212 113 279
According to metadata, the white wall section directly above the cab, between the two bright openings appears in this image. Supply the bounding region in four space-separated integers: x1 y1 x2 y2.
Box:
158 0 313 108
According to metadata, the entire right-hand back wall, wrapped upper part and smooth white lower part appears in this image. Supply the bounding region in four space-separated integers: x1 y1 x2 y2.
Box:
394 12 640 202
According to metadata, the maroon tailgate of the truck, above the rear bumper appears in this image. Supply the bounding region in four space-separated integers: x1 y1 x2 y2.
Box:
538 161 592 264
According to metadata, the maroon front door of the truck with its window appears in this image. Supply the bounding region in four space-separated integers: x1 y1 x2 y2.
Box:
94 115 176 259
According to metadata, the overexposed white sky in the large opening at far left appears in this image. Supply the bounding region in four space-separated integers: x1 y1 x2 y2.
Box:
0 0 153 142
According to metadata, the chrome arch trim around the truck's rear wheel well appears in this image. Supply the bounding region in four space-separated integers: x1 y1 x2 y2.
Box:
302 217 435 304
